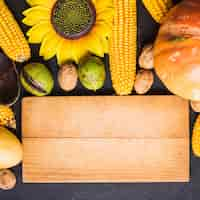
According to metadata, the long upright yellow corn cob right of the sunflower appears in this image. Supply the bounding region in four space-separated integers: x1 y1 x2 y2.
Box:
109 0 137 95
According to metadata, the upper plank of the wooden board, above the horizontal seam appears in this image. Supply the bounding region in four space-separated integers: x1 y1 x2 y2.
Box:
22 96 189 138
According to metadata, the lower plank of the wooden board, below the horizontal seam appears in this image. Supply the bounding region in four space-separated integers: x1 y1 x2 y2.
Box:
23 138 189 183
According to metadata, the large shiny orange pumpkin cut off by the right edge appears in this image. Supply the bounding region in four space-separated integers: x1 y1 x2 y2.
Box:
154 0 200 101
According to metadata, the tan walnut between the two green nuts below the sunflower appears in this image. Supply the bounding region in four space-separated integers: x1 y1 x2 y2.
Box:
58 63 78 92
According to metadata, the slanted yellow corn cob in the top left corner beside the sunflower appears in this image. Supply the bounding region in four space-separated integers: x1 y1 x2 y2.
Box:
0 0 30 62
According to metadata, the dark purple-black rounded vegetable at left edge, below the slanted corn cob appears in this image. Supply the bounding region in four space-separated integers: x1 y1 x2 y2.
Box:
0 52 20 106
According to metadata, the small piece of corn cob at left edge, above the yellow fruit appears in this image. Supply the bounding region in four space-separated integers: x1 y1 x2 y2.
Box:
0 105 16 128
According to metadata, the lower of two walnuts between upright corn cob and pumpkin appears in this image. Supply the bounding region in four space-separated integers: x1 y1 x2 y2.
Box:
134 69 154 94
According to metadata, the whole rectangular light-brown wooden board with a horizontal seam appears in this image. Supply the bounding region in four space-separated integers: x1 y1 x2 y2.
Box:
22 96 189 183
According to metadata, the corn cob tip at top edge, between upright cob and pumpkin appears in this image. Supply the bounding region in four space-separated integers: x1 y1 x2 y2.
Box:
143 0 173 23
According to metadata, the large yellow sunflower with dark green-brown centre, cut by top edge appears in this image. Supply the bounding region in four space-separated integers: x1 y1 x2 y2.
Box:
23 0 114 65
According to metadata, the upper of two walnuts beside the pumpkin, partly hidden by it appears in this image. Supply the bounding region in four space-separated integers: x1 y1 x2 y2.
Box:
139 44 154 69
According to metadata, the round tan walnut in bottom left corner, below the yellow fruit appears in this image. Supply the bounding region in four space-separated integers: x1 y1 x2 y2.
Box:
0 169 16 190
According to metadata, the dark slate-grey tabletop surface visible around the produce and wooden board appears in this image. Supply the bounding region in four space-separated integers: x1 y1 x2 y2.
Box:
0 0 200 200
